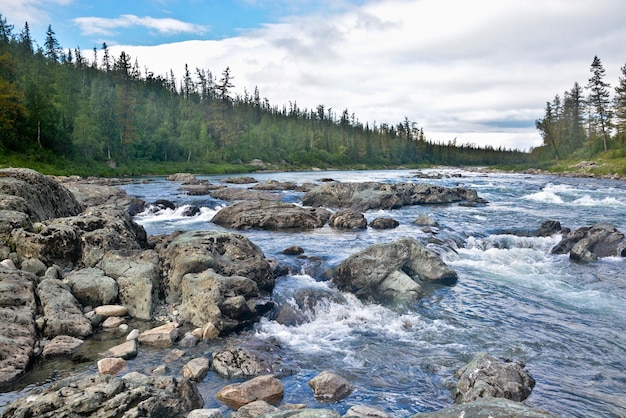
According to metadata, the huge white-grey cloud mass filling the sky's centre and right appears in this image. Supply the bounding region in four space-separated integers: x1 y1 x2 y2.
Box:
106 0 626 149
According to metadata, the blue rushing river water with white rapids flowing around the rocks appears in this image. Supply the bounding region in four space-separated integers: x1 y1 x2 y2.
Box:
0 169 626 417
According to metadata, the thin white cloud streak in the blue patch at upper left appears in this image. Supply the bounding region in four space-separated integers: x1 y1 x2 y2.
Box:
74 14 207 36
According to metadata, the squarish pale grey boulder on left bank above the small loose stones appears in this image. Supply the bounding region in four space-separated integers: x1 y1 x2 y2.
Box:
63 267 118 306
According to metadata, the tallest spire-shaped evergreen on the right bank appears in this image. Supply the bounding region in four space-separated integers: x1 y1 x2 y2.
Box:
587 55 612 151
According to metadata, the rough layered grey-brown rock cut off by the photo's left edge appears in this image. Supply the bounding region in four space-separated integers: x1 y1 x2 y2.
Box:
0 265 37 385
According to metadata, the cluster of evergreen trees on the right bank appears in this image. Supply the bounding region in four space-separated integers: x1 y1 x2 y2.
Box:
532 56 626 159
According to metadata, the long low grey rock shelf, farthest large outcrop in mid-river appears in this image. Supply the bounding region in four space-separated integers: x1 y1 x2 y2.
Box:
302 182 485 211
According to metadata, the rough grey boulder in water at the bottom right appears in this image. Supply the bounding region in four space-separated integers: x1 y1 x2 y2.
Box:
452 353 535 403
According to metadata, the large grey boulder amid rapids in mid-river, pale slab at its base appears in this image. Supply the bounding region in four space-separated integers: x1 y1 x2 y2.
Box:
332 238 457 303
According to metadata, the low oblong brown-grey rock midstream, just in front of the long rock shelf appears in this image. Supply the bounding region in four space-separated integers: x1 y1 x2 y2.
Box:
212 201 331 230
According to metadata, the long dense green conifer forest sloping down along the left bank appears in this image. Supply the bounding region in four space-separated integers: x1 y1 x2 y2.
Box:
0 15 527 172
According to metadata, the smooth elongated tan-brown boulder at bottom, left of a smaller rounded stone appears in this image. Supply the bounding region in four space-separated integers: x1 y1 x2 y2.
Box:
215 375 285 410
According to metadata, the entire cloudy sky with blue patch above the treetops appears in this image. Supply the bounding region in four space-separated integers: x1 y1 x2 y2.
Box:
0 0 626 150
